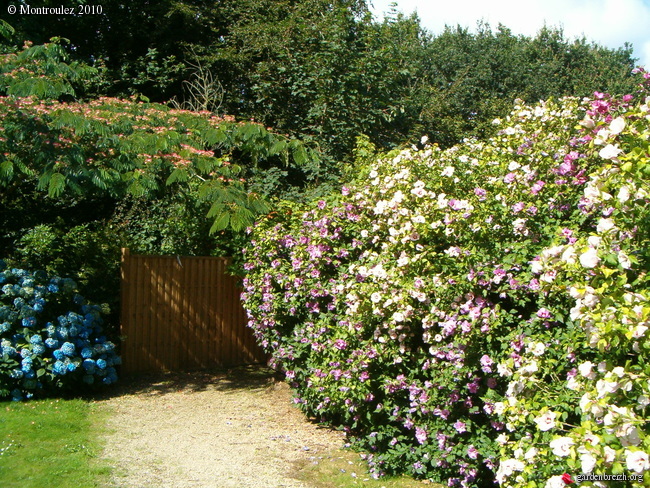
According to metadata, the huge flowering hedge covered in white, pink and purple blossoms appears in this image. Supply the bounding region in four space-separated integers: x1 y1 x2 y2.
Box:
243 72 650 488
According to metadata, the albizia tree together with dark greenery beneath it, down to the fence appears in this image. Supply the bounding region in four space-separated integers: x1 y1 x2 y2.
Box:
0 27 319 313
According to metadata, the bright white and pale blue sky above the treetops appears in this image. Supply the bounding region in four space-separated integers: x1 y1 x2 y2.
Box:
369 0 650 70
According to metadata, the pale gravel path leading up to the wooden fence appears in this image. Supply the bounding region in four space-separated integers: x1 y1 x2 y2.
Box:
99 368 343 488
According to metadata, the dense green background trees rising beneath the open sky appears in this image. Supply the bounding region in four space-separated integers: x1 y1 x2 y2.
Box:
3 0 634 162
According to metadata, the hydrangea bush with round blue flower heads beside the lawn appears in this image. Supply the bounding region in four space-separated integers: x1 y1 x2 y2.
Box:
0 261 120 400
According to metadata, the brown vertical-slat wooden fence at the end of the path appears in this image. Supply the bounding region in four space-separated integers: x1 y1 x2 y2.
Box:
121 249 265 373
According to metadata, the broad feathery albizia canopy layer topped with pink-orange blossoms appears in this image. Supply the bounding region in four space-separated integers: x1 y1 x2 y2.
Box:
0 96 316 234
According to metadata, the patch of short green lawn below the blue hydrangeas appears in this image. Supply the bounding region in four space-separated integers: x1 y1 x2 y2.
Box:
0 399 110 488
